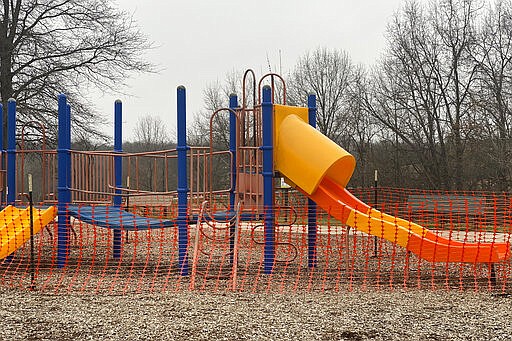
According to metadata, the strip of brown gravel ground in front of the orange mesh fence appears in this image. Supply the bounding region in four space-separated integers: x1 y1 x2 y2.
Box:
0 289 512 340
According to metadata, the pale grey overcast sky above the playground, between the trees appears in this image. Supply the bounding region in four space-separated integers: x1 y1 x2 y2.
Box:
93 0 403 141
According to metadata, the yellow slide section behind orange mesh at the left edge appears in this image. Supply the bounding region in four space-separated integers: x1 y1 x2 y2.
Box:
0 205 57 259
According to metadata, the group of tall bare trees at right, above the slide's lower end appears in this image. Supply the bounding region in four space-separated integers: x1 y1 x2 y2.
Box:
357 0 512 191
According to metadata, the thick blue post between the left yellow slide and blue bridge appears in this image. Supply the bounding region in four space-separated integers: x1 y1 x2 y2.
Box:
57 94 71 268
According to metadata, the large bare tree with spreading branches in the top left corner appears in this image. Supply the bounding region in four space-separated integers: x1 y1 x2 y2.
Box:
0 0 153 144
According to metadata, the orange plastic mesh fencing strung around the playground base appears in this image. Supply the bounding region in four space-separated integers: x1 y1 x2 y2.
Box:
0 188 512 294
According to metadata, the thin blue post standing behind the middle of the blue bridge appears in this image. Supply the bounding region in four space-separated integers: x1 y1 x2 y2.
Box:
113 100 123 259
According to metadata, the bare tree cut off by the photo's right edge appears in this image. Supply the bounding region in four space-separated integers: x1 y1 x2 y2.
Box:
471 0 512 190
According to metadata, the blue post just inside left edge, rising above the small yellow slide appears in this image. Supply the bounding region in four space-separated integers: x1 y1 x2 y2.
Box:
7 98 16 205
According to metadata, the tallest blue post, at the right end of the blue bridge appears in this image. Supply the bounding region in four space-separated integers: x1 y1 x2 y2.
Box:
176 85 189 276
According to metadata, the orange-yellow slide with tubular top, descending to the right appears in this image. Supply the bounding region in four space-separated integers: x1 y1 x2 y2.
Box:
274 105 511 263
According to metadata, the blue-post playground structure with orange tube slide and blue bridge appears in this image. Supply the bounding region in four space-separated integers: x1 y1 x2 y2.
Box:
0 70 511 288
